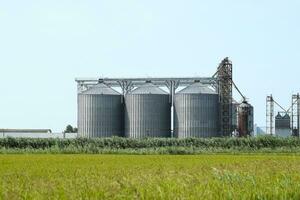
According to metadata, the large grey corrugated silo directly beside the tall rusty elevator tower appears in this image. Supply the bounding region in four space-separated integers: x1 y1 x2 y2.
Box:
174 83 219 138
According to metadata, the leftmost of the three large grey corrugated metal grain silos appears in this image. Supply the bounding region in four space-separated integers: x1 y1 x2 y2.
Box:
78 83 123 138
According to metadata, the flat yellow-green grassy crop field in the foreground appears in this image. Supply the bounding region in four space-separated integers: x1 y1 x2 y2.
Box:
0 154 300 200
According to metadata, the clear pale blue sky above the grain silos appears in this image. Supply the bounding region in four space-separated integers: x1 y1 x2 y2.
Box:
0 0 300 131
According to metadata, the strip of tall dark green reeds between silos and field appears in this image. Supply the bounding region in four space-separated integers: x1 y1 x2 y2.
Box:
0 136 300 154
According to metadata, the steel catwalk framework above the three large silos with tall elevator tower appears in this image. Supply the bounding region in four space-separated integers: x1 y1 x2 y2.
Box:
75 57 233 136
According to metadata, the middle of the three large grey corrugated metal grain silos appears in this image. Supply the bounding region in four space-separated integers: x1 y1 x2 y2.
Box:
125 83 171 138
